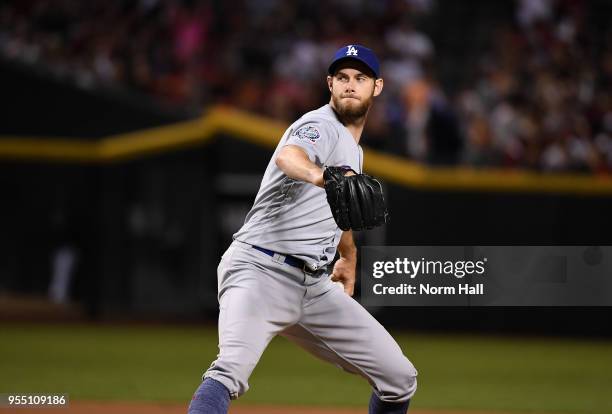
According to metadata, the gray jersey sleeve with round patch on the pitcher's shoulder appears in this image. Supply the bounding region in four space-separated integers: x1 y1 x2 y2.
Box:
285 121 338 167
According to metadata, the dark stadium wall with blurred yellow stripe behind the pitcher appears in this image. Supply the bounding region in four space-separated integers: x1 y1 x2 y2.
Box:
0 65 612 336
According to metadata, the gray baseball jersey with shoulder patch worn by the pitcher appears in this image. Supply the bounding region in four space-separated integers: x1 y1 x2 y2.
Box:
234 105 363 269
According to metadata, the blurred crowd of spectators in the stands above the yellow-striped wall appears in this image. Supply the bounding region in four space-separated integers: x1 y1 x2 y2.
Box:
0 0 612 173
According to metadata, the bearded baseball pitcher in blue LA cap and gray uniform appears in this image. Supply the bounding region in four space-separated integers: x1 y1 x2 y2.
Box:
189 45 417 414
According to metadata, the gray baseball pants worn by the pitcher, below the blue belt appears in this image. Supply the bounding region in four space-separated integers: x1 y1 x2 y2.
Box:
204 240 417 402
